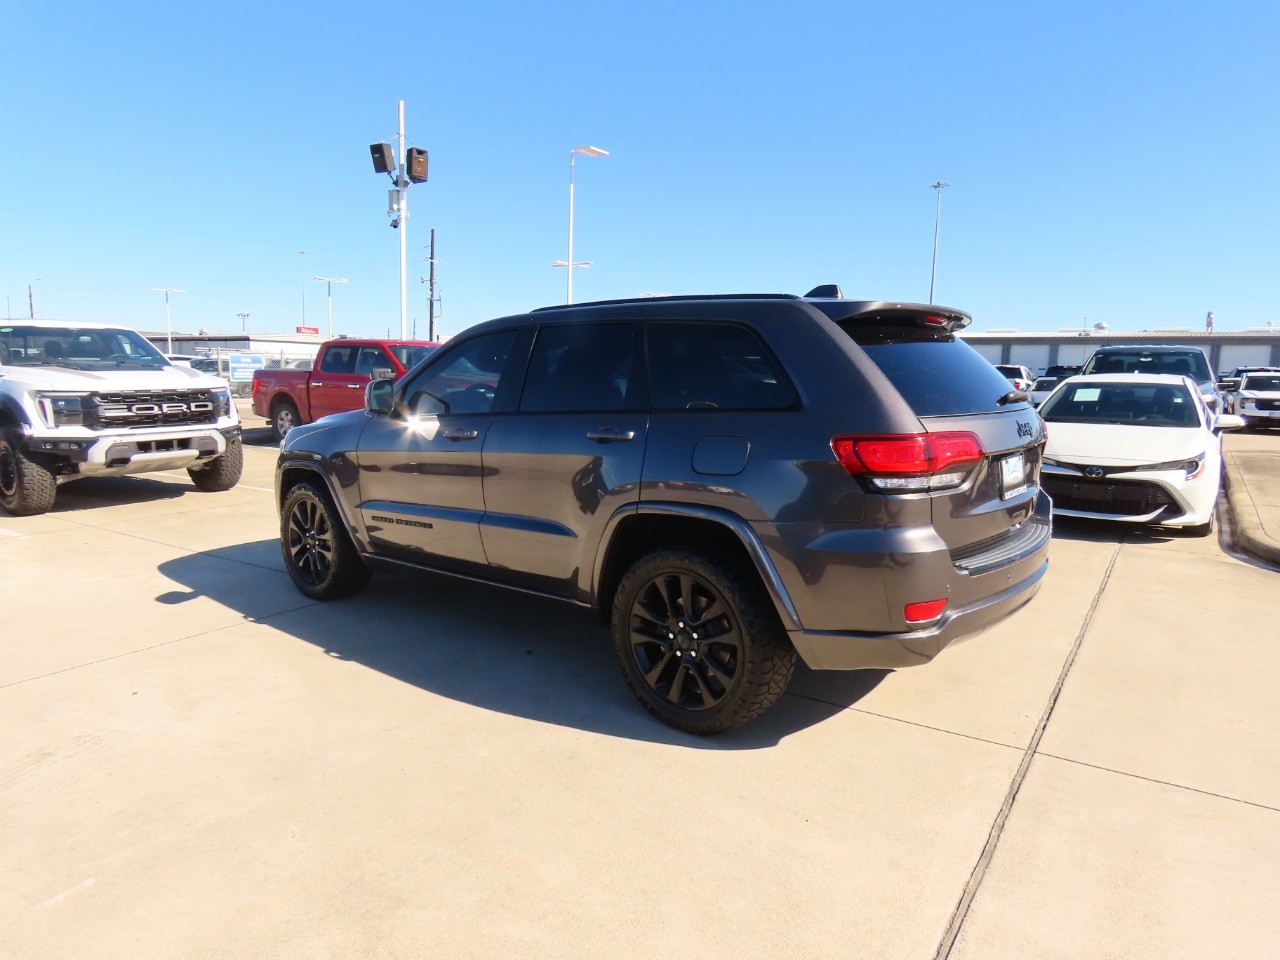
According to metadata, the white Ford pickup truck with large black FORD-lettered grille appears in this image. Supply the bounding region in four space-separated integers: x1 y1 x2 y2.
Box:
0 320 243 516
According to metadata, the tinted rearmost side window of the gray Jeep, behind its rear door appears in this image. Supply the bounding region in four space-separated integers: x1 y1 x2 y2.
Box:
648 321 796 410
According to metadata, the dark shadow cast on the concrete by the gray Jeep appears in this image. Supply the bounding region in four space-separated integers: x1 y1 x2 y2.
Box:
156 540 887 750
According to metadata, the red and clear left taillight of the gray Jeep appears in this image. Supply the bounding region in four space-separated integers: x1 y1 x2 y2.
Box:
831 431 987 492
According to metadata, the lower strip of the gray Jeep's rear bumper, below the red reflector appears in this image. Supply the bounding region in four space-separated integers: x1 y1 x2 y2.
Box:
788 558 1048 669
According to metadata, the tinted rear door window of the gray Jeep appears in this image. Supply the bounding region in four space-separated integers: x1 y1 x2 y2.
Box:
520 324 635 413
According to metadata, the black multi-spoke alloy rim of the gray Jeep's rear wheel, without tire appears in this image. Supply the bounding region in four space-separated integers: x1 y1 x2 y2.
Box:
630 572 744 712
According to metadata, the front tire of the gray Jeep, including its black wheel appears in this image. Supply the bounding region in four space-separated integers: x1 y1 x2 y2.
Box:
280 483 371 600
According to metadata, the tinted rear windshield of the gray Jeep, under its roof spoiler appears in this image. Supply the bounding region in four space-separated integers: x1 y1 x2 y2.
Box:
840 315 1010 417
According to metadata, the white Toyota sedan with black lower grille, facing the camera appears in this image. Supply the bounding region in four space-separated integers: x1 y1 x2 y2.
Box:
1039 374 1244 536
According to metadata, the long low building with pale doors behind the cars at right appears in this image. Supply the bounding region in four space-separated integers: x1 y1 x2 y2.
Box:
961 324 1280 374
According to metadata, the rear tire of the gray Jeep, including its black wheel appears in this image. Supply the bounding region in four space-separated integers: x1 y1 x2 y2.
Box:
612 549 796 733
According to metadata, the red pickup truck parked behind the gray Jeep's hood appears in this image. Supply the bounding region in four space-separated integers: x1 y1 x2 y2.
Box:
253 339 439 436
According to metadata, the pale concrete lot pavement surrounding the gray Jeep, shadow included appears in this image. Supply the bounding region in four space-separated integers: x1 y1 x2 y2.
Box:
0 421 1280 960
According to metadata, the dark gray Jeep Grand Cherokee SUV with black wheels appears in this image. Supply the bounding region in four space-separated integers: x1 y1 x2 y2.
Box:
276 294 1050 733
